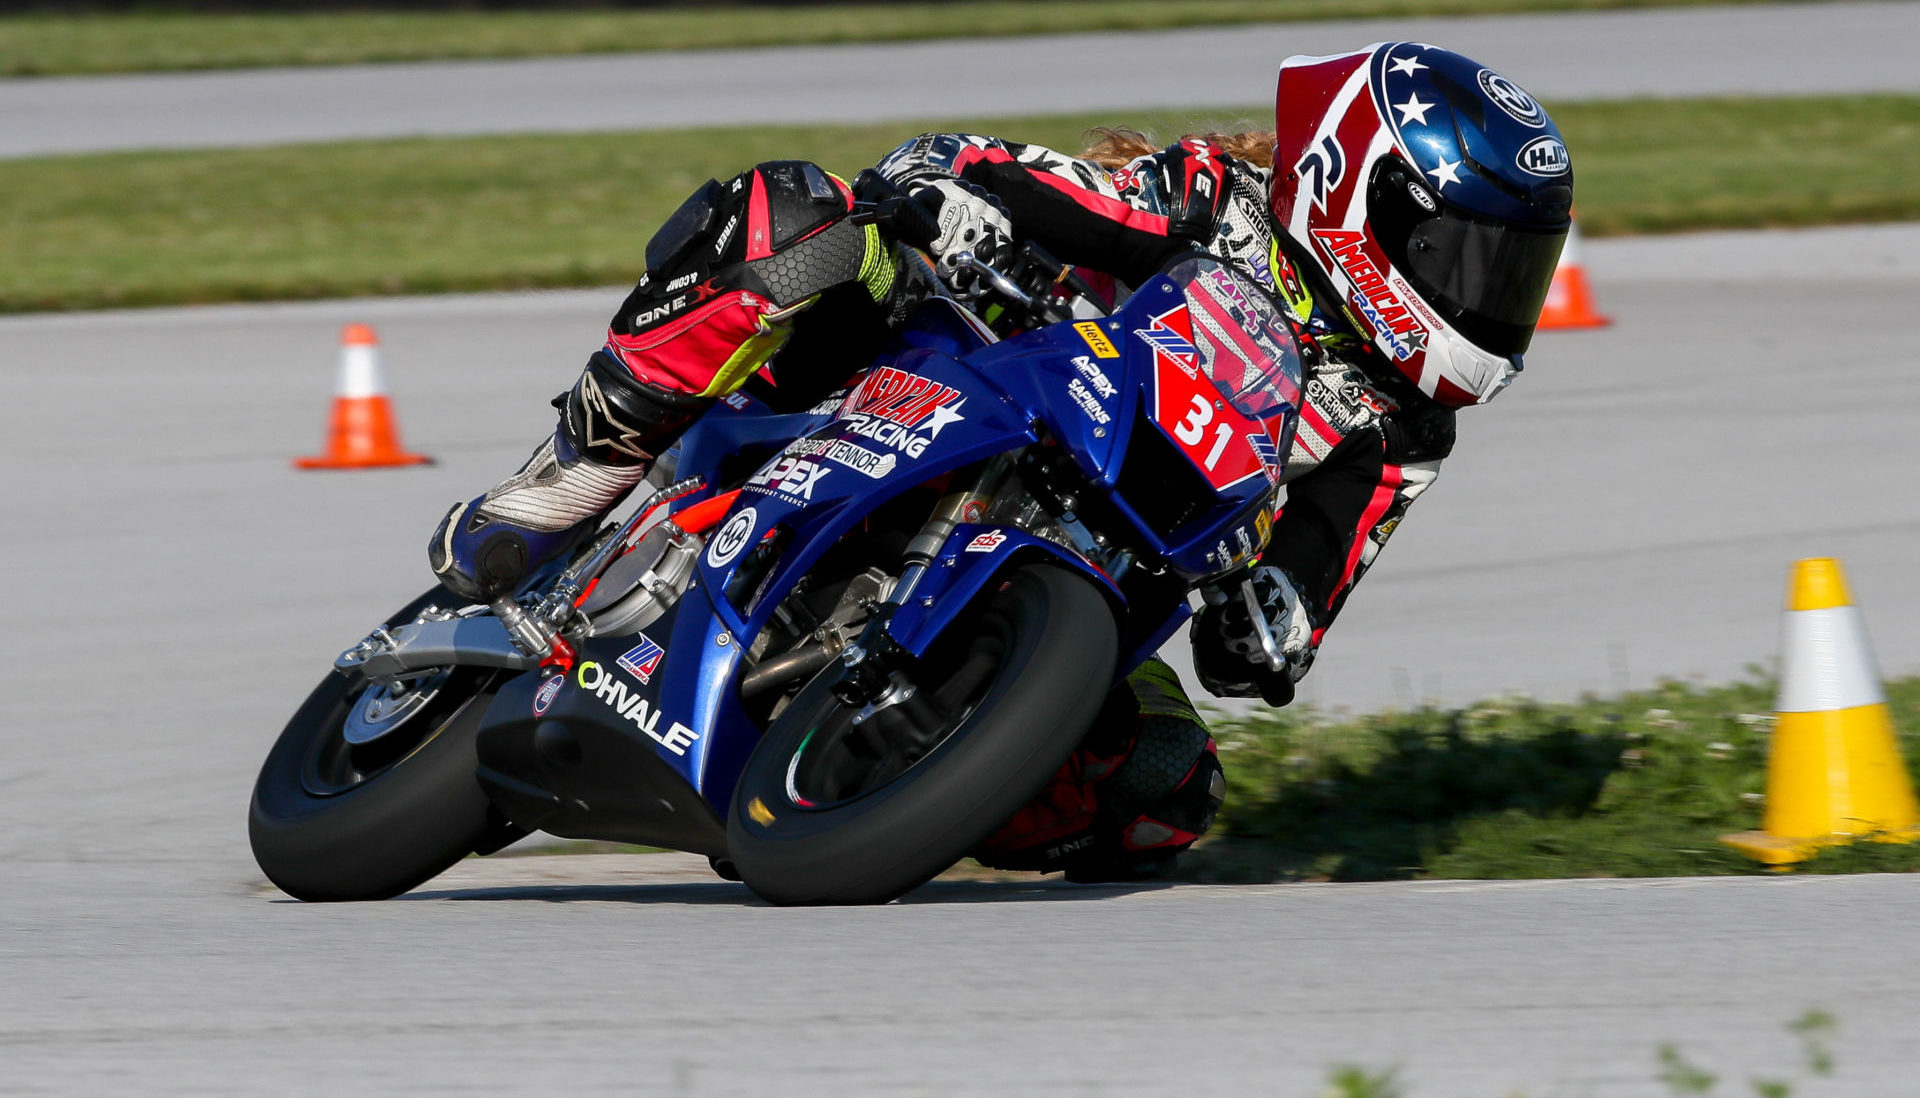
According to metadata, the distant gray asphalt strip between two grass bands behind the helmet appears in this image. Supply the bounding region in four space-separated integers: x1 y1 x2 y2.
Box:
0 2 1920 157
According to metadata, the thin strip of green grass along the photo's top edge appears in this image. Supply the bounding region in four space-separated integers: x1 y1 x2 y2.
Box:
0 0 1812 77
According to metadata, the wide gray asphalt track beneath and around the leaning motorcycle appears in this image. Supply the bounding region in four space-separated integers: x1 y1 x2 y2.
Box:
0 227 1920 1098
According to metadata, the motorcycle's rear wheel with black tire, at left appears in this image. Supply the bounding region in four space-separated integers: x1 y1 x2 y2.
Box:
248 587 516 900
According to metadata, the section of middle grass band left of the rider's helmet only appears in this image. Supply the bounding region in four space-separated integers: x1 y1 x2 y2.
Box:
0 106 1274 311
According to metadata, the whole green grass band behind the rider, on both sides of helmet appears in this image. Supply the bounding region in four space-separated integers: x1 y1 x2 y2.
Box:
0 96 1920 311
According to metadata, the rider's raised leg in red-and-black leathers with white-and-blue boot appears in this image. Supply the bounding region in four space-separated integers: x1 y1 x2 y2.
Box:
426 161 893 601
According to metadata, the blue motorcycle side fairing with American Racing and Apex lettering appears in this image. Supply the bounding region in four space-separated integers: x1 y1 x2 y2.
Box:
682 266 1273 671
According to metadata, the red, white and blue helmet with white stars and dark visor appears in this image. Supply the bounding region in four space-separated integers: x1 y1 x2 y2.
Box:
1271 42 1572 407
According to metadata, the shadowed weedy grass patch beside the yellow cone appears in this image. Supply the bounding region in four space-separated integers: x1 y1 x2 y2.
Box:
1183 678 1920 881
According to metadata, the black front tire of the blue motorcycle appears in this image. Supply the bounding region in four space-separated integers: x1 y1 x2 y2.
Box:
728 566 1119 904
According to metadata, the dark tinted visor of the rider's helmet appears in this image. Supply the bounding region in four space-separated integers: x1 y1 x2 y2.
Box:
1369 161 1567 355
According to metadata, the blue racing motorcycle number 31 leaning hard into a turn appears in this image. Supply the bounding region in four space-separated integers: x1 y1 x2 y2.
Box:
250 184 1302 904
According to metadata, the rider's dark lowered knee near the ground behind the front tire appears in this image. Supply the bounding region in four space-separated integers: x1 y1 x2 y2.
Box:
973 658 1227 881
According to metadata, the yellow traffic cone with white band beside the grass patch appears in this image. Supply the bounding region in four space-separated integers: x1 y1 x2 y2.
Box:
1720 557 1920 870
